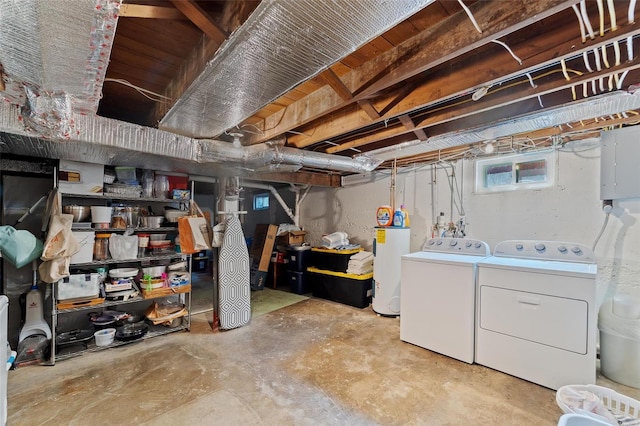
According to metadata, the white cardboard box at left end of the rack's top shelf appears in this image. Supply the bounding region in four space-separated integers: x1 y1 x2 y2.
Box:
58 160 104 195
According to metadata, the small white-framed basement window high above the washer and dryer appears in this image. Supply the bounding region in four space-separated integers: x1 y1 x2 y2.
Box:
475 150 556 193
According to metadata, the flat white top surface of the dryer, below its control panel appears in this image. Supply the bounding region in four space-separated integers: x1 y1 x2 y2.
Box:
478 256 598 278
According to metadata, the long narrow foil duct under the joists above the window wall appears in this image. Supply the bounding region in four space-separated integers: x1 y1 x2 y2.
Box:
364 91 640 161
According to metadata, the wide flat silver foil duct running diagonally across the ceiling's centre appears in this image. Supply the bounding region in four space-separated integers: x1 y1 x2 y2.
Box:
160 0 433 138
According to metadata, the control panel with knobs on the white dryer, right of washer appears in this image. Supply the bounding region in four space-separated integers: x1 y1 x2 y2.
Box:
493 240 596 263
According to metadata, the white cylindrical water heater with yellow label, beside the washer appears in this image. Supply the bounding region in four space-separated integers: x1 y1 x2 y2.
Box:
371 226 411 317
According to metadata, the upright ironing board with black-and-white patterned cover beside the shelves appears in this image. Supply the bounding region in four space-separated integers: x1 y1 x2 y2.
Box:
218 216 251 330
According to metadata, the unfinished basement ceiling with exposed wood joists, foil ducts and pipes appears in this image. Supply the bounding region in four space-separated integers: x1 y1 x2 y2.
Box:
0 0 640 185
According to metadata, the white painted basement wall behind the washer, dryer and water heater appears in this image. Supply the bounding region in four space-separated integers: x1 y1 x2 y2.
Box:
301 141 640 303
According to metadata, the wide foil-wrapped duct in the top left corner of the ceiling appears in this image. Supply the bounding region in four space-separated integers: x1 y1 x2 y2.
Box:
0 0 120 114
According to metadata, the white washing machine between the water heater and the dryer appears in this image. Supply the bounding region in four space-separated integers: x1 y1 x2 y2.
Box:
400 238 491 364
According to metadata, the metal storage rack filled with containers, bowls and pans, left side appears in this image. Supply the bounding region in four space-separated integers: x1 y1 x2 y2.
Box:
50 160 191 364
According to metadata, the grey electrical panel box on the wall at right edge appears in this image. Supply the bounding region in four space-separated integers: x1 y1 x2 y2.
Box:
600 126 640 200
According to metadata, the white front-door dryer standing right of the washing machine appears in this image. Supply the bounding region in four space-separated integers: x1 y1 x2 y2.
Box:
476 240 597 389
